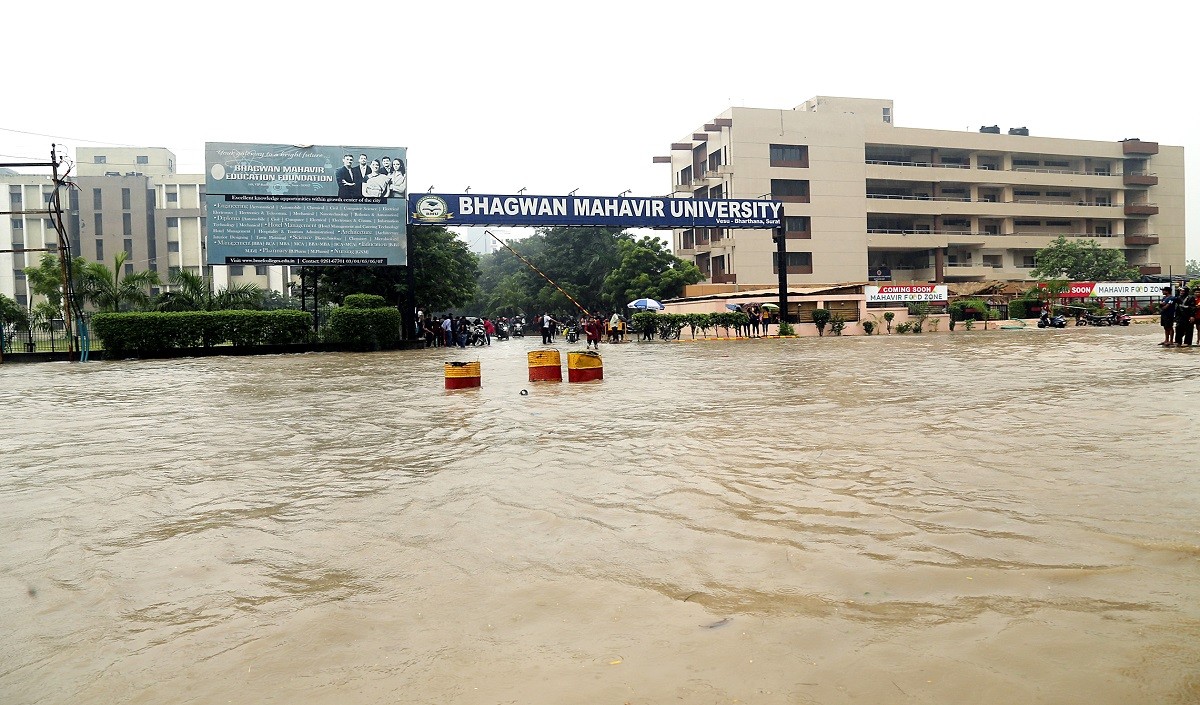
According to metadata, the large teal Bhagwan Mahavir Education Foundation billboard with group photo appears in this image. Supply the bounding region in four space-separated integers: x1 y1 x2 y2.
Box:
204 141 408 266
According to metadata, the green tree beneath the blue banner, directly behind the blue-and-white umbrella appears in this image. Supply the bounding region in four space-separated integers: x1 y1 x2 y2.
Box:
601 235 704 308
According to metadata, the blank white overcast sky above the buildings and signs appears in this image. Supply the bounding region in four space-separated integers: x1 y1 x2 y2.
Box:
0 0 1200 259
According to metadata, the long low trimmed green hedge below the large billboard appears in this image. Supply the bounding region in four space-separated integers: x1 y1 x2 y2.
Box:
91 309 312 356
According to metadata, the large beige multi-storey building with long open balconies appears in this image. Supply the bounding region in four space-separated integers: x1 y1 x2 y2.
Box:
654 97 1186 287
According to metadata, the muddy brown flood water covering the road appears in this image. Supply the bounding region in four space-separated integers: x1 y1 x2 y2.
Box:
0 325 1200 705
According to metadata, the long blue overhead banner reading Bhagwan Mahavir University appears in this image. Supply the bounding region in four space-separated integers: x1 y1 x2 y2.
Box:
409 193 784 229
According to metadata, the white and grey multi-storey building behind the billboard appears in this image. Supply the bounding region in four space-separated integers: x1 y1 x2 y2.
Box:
0 147 292 306
